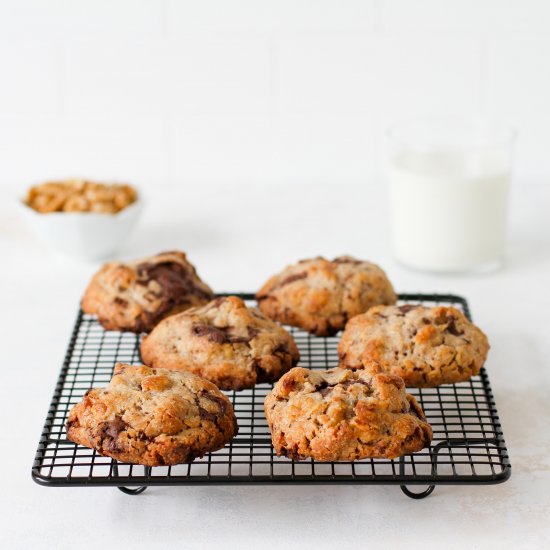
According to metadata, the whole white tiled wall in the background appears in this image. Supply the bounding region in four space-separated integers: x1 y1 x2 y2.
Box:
0 0 550 189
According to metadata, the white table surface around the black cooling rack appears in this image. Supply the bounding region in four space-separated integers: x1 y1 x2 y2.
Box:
0 185 550 549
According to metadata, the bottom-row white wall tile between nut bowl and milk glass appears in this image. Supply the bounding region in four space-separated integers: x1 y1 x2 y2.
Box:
170 113 374 184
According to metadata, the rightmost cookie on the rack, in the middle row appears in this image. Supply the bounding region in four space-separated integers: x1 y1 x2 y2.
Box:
338 305 489 388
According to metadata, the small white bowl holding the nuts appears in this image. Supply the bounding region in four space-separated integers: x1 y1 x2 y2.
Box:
19 197 143 260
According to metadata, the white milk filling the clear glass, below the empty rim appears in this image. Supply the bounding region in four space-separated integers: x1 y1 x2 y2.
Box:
389 150 510 272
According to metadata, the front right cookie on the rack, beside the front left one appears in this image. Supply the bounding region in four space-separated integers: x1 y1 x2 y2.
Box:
264 365 432 462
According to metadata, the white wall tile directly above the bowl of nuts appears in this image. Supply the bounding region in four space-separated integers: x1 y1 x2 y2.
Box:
0 113 169 190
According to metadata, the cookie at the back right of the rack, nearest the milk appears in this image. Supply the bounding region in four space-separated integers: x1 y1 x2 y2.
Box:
256 256 396 336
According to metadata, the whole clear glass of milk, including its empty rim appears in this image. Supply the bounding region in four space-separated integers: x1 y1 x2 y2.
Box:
389 119 516 273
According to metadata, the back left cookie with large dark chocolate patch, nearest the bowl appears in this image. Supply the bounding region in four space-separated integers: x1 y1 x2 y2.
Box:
82 252 214 333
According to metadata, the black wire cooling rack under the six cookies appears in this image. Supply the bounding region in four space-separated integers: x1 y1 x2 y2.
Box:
32 294 511 498
